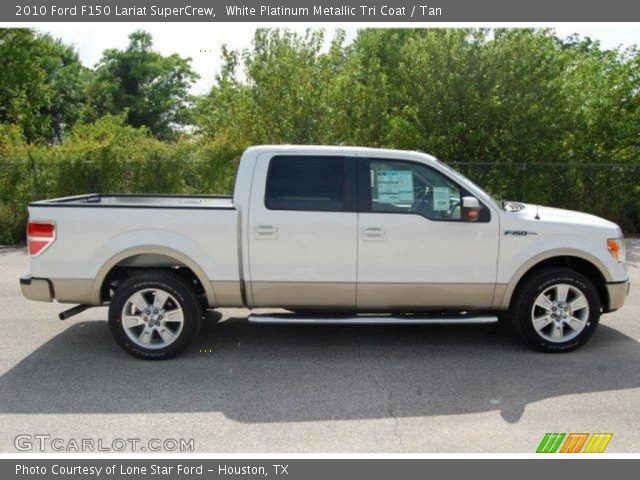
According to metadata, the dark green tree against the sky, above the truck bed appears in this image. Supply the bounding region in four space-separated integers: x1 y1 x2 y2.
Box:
85 31 198 140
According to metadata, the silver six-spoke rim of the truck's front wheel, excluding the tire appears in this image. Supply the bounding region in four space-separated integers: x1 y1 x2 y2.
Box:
531 283 589 343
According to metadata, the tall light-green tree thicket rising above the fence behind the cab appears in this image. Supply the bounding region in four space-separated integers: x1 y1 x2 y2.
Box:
196 28 640 167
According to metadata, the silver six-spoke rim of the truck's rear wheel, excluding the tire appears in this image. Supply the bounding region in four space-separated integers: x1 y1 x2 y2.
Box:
122 288 184 349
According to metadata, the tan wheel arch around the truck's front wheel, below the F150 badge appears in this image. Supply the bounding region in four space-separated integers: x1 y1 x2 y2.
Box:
494 249 612 311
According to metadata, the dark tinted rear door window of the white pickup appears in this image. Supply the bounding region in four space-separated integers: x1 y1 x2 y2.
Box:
265 155 345 212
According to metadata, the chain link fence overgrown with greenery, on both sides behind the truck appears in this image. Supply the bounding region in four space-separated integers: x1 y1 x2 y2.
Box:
0 159 640 244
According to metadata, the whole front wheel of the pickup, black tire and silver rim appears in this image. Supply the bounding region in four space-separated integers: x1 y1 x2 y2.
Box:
509 268 601 353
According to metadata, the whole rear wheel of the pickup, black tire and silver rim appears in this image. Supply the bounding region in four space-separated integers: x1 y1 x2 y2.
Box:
109 271 202 360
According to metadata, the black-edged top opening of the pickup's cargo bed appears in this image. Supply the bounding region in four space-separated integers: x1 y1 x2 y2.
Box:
29 193 233 209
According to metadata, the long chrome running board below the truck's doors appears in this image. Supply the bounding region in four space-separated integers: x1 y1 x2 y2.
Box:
247 314 498 325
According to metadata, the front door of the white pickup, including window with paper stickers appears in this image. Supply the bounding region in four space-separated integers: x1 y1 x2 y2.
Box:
357 158 499 310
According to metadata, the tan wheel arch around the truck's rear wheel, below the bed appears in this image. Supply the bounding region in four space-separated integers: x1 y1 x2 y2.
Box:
91 245 216 305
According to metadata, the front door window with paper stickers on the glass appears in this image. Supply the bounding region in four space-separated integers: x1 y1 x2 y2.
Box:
369 160 463 220
